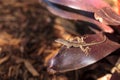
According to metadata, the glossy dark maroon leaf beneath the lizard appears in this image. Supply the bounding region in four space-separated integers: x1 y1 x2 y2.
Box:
48 34 120 72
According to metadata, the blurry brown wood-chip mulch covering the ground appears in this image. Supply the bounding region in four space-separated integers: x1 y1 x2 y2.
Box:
0 0 119 80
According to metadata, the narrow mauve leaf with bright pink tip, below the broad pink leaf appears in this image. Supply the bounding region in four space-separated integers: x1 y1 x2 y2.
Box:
45 0 113 33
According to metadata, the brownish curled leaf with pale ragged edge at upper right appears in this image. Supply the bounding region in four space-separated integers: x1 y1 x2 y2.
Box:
95 7 120 26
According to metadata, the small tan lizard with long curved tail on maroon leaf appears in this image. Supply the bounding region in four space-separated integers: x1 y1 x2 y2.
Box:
55 36 107 54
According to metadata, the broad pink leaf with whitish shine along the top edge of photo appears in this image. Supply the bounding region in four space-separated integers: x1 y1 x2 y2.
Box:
47 0 109 12
